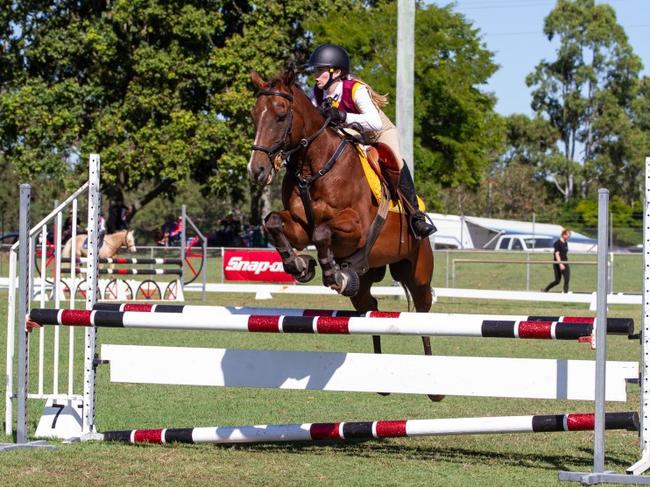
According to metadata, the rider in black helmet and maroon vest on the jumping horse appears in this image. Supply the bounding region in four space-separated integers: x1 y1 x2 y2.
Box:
309 44 436 239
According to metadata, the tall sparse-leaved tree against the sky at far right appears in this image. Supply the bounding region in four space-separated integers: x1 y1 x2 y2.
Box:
526 0 641 202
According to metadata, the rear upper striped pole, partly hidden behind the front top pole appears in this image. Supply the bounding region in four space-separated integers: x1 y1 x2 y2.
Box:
88 303 634 336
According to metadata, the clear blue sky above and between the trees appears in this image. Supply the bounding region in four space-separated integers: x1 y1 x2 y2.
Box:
428 0 650 115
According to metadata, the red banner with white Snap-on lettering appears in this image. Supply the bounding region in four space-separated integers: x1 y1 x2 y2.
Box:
223 249 296 283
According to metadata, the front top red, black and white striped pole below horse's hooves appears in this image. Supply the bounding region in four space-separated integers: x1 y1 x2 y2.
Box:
29 308 628 340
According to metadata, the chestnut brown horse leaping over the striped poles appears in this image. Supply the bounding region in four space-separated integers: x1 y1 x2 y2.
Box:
247 71 442 400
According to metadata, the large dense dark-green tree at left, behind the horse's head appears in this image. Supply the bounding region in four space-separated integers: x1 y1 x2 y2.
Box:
0 0 353 225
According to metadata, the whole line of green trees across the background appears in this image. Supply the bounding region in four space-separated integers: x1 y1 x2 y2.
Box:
0 0 650 244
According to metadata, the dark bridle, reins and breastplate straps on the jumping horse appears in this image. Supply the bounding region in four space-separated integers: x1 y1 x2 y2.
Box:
252 89 349 236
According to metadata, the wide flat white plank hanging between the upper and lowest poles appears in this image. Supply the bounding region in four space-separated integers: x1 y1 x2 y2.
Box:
101 345 638 401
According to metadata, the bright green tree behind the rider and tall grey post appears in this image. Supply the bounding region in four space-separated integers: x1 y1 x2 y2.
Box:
309 2 501 194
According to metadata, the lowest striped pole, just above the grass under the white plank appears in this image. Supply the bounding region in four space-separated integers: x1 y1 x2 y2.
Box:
93 412 639 444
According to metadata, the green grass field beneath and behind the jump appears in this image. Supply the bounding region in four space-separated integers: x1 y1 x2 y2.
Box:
0 254 641 486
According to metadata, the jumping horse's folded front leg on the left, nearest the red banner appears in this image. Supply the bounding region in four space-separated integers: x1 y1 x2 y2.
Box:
264 211 316 282
